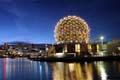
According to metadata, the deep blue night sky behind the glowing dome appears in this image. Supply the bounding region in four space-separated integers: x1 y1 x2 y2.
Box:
0 0 120 43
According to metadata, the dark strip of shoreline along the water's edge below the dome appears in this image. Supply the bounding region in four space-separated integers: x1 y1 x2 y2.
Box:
28 56 120 62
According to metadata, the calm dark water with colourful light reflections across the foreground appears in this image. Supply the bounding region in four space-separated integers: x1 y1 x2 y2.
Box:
0 58 120 80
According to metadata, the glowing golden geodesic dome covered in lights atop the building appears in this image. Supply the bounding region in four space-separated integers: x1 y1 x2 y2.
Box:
54 16 90 43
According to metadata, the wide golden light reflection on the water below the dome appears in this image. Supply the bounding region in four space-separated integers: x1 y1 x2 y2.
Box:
53 62 93 80
